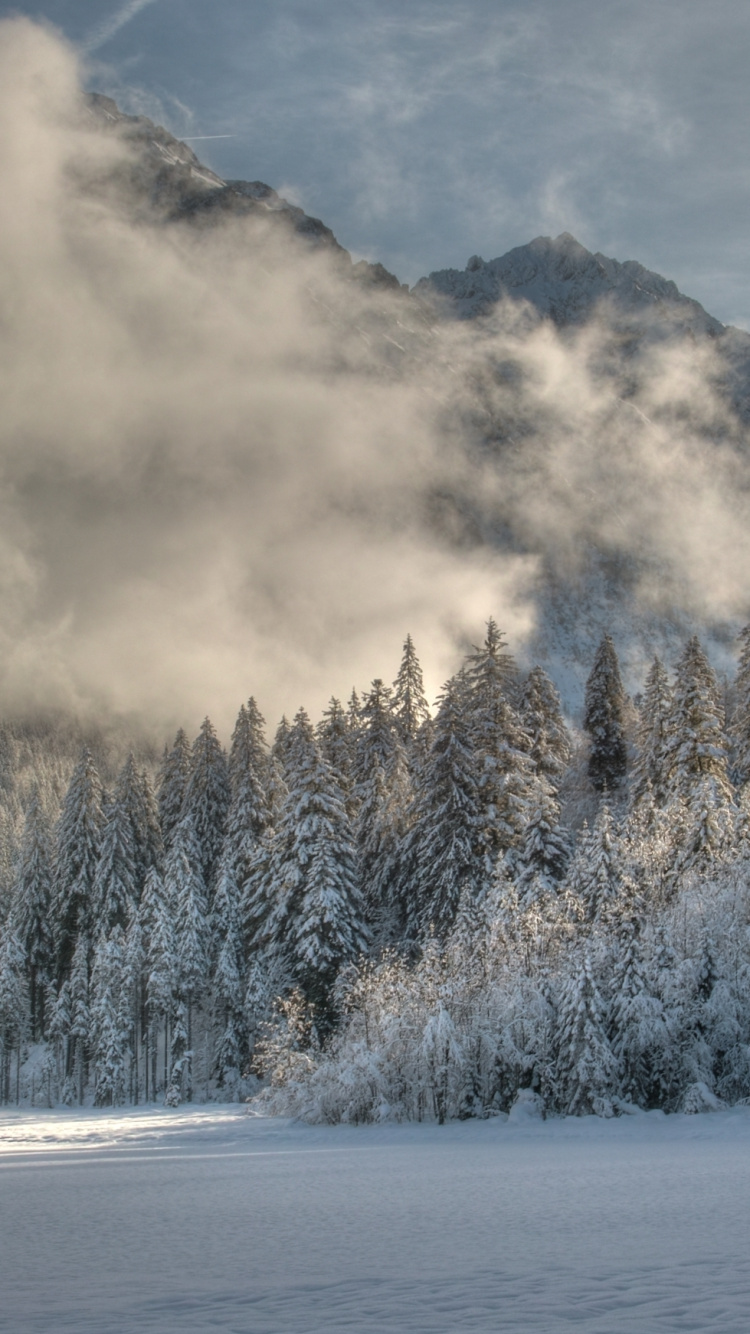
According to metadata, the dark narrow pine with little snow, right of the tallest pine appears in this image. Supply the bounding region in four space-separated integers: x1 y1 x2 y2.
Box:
583 635 627 792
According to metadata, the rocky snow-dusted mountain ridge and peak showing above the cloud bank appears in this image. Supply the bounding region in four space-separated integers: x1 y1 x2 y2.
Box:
88 93 750 408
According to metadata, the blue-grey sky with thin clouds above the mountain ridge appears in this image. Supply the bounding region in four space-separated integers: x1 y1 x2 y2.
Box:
0 0 750 327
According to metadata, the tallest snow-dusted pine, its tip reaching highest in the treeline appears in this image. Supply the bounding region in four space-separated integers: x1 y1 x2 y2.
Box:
462 619 531 869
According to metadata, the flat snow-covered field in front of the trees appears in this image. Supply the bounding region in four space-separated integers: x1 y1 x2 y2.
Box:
0 1107 750 1334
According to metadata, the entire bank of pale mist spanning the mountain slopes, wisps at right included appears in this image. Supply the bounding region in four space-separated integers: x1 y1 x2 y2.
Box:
0 20 750 732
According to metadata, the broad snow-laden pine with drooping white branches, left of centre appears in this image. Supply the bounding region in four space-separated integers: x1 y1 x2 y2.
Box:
266 710 368 1018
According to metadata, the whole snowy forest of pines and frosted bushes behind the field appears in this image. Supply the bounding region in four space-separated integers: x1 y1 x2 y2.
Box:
0 622 750 1119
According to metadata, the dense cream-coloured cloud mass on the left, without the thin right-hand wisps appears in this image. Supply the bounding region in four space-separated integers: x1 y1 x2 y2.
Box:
0 21 534 727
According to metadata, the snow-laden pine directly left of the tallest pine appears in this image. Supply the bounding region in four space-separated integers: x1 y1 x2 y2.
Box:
399 676 484 942
